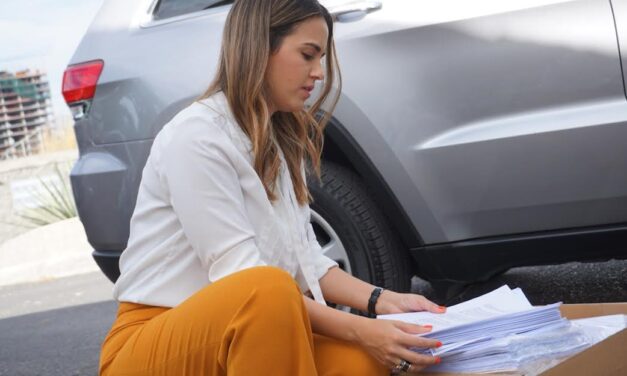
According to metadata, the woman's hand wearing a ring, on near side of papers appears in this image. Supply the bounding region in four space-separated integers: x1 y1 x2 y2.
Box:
357 317 442 373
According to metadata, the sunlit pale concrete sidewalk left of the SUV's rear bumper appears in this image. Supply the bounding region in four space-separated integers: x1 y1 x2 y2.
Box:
0 218 99 286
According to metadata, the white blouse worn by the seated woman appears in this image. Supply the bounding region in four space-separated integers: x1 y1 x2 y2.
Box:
113 92 337 307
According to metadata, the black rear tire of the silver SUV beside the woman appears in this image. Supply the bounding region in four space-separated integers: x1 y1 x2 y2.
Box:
309 162 413 292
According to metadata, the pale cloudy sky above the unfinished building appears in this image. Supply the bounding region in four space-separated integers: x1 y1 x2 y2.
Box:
0 0 103 118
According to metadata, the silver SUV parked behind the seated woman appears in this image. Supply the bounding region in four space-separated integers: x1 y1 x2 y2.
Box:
63 0 627 290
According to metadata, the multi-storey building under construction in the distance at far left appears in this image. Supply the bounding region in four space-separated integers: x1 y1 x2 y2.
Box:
0 70 54 160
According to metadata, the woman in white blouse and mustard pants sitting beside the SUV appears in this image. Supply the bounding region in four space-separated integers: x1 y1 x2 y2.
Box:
100 0 444 376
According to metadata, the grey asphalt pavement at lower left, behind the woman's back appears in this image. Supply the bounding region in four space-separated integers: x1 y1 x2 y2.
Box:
0 272 117 376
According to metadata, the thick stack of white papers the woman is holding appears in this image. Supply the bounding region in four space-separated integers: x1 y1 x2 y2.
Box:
378 286 588 372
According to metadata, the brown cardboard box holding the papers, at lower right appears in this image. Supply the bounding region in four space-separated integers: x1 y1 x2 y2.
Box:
426 303 627 376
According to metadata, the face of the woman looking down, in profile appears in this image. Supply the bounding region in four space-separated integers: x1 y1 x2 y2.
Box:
265 17 329 113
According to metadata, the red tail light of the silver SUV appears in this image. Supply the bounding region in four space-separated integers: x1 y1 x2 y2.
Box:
62 60 104 120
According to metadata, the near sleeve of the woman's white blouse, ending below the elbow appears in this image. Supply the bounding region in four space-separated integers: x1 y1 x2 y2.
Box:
159 118 266 282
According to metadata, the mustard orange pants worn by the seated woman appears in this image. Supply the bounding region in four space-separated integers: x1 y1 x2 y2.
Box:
100 267 389 376
